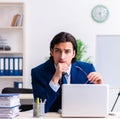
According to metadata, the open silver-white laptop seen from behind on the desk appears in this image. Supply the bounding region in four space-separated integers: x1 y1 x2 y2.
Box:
61 84 109 117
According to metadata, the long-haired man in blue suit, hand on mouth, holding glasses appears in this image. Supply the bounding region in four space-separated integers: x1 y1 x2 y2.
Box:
31 32 103 112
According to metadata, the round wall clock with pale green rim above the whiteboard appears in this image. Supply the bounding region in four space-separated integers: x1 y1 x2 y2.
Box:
91 5 109 23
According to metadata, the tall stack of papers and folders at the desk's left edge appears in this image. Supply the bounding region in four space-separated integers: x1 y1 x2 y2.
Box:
0 94 20 119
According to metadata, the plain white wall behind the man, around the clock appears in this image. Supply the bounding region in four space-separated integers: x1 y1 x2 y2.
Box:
0 0 120 112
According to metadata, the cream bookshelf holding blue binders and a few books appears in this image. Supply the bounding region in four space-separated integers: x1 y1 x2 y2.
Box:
0 2 25 91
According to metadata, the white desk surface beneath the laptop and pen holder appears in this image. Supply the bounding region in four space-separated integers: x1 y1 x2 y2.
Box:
15 110 120 119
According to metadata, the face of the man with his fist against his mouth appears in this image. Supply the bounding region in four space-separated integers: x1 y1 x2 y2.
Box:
51 42 75 66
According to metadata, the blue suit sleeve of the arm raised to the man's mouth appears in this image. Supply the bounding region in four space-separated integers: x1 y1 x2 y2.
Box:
31 69 60 112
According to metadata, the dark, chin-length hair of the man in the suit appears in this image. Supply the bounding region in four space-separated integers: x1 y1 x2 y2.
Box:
50 32 77 63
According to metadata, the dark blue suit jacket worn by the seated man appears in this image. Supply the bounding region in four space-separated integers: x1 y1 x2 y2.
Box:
31 60 95 112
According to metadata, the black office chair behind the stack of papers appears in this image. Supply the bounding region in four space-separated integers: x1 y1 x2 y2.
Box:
1 87 33 112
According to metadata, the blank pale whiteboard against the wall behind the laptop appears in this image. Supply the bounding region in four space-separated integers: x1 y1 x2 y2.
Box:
96 35 120 88
